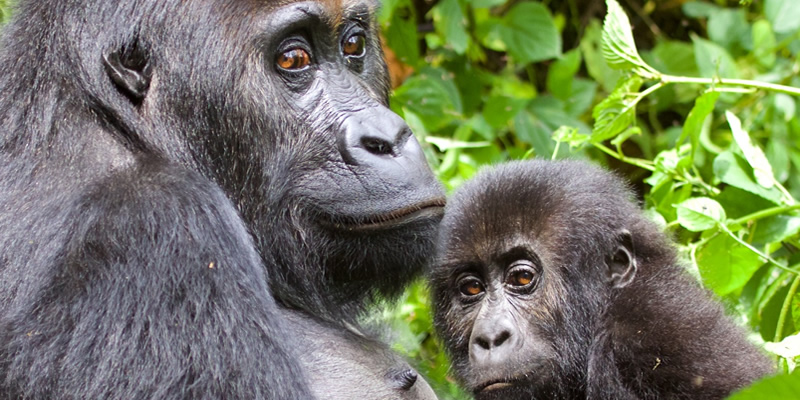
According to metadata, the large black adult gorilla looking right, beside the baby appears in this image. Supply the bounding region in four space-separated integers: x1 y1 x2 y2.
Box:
0 0 443 399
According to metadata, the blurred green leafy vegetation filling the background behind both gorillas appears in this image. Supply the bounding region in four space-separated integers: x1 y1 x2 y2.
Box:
0 0 800 399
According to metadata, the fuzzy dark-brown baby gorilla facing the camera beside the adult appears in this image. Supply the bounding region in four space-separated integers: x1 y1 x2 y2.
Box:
432 161 772 400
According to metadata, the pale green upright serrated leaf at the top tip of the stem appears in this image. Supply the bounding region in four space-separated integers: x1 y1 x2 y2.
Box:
602 0 651 74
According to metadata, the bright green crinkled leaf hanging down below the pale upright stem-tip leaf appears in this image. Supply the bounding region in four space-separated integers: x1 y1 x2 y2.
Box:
592 75 642 143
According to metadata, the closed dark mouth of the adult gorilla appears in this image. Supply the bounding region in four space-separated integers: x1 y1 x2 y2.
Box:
332 197 446 231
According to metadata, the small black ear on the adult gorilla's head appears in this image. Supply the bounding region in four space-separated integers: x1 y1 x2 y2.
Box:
103 39 153 105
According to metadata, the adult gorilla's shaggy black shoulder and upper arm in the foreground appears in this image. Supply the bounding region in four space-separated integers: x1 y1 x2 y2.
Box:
0 162 311 399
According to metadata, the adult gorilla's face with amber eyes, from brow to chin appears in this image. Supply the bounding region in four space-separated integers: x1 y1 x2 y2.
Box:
129 0 444 313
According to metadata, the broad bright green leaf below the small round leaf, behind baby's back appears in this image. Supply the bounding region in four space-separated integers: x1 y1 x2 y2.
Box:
697 233 763 296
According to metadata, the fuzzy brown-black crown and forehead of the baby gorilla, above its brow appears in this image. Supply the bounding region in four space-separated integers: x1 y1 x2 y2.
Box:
440 160 637 260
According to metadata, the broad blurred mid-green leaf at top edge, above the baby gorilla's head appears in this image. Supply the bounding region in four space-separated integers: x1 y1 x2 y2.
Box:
499 2 561 64
